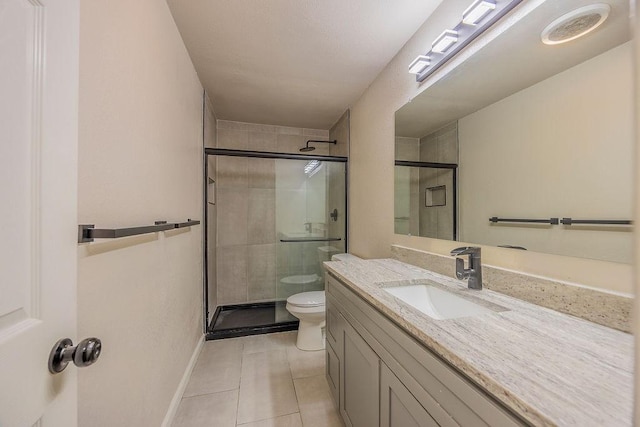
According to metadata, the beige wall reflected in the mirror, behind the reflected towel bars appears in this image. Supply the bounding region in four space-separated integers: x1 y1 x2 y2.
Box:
459 42 635 263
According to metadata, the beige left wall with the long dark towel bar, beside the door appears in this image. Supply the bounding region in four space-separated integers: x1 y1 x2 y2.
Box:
78 0 202 426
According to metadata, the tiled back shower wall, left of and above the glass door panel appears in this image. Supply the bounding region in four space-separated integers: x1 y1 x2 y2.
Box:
216 120 330 310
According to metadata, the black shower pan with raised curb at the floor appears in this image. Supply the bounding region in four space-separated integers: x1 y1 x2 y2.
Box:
206 301 299 341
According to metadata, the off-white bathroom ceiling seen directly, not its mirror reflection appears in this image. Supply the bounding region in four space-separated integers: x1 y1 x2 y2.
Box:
167 0 442 129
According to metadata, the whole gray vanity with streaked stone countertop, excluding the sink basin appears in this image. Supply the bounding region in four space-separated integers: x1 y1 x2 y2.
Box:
325 259 633 427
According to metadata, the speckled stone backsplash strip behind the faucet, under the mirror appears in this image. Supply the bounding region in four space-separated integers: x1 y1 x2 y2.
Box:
391 245 633 333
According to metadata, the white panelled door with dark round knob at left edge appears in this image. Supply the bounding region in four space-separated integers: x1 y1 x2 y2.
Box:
0 0 79 427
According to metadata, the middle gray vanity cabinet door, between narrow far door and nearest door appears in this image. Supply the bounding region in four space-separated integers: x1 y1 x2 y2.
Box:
340 322 380 427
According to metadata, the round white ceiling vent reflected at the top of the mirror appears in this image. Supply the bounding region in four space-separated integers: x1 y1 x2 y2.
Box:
541 3 611 44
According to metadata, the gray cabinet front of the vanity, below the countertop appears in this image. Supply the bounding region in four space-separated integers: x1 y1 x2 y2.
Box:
325 274 527 427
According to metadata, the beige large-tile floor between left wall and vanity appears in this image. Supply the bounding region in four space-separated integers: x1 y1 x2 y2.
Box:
173 331 343 427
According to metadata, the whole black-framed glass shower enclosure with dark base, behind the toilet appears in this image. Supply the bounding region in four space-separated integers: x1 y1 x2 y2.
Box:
205 148 347 339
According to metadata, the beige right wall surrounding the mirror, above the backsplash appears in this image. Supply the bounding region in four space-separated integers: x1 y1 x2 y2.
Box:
349 0 633 293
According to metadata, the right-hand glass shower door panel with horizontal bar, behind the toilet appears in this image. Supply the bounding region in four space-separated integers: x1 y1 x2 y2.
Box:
276 160 346 321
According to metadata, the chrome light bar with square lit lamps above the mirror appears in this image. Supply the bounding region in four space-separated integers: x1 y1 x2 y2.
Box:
409 0 522 82
